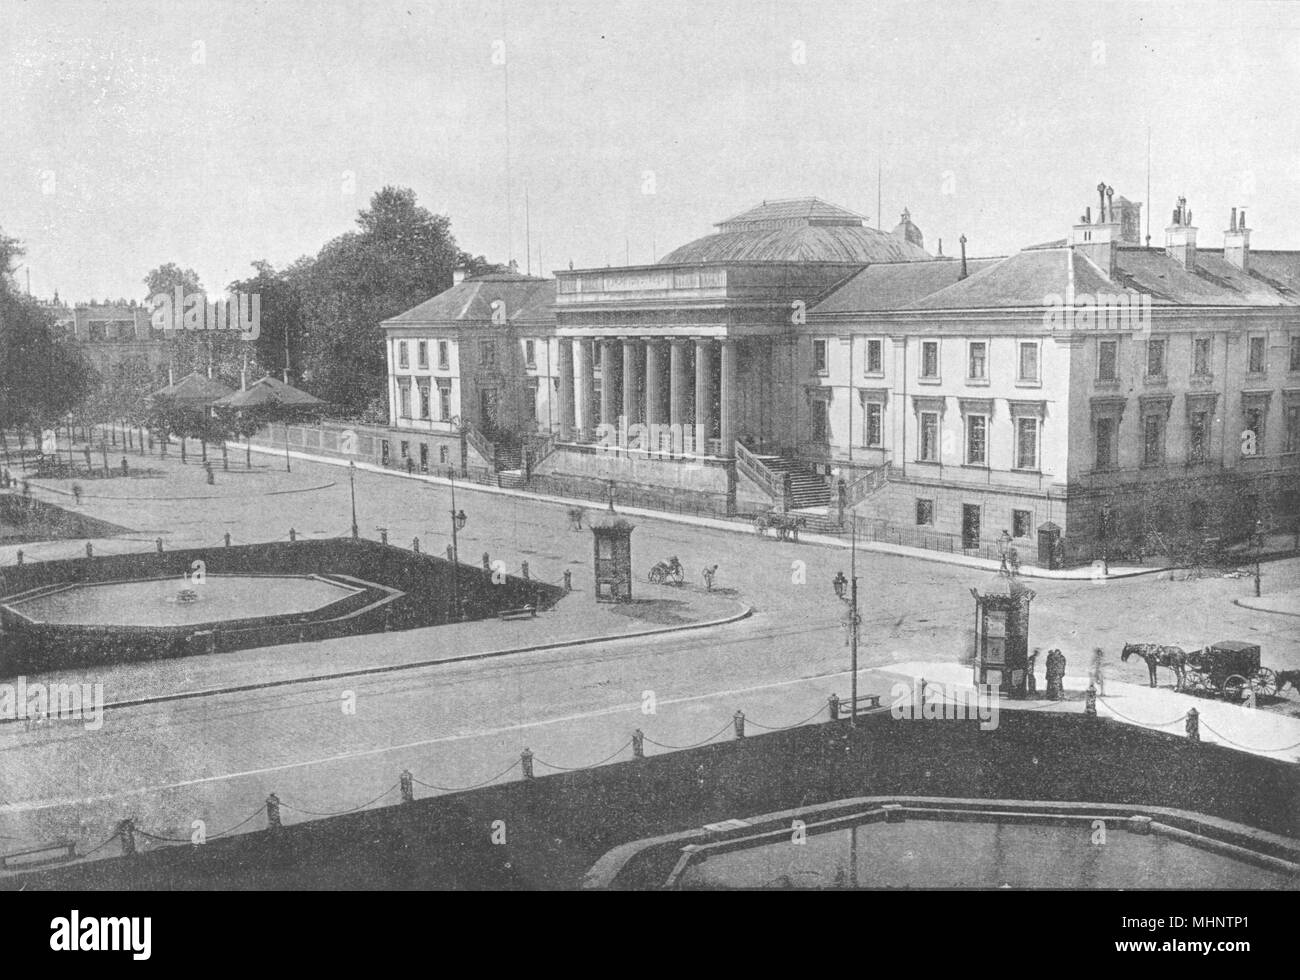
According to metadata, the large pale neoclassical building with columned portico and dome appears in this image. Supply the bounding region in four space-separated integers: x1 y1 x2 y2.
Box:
384 192 1300 560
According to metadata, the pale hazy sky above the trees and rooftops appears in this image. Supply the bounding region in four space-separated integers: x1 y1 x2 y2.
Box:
0 0 1300 300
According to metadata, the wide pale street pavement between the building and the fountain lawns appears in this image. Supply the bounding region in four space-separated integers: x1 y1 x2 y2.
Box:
0 439 1300 868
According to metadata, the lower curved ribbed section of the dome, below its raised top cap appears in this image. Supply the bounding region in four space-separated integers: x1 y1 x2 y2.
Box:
659 225 932 265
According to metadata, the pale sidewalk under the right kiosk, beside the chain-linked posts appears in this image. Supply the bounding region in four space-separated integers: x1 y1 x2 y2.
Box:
868 662 1300 762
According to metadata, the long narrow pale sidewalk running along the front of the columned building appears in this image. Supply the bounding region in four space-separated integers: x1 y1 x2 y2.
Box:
233 443 1169 581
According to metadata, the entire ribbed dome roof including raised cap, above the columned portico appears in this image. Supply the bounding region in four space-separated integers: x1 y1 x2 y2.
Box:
659 198 932 265
